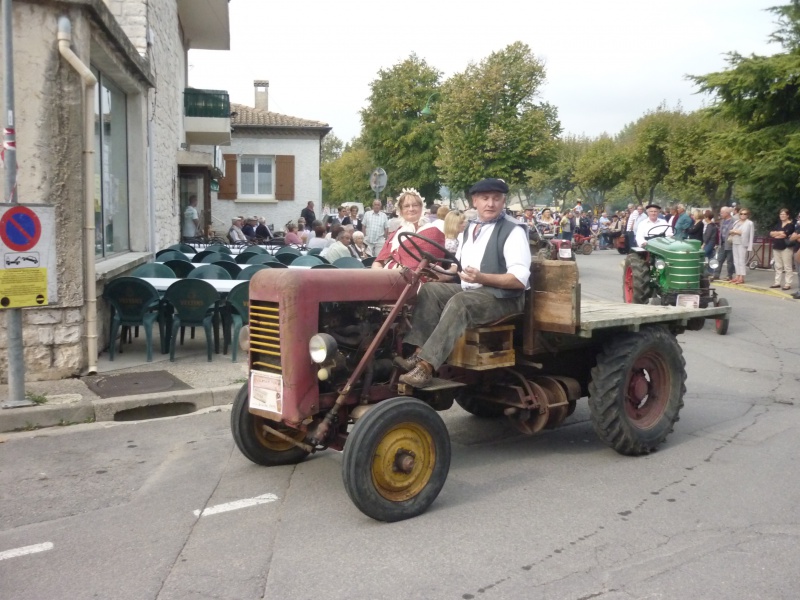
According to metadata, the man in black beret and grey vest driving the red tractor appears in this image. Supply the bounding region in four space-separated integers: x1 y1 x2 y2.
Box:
395 179 531 388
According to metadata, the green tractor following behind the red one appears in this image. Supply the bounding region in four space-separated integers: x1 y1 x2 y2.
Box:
622 227 728 335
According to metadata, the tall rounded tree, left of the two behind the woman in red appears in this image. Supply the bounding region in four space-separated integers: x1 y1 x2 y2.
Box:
361 54 441 199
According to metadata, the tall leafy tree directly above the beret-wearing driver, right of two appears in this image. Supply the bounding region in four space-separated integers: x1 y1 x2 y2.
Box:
436 42 561 197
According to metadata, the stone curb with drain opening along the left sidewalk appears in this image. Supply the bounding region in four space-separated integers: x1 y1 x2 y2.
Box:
0 385 241 433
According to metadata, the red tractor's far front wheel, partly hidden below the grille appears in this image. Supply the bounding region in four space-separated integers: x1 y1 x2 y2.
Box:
231 383 308 467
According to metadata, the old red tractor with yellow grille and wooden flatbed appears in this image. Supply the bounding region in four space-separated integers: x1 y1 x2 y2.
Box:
231 233 729 521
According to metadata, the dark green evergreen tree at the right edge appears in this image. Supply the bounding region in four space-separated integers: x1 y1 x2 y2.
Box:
690 0 800 212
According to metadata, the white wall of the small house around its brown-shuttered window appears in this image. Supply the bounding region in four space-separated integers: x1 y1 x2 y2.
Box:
211 132 322 233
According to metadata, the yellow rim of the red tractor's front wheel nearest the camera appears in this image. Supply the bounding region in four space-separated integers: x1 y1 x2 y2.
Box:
372 423 436 502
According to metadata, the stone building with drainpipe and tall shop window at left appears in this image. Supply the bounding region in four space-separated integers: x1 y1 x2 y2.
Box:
0 0 230 381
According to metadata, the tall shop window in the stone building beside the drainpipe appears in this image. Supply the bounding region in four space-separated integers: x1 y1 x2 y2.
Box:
92 68 130 256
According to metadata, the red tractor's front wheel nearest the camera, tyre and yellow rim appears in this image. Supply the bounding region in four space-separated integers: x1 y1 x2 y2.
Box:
342 397 450 522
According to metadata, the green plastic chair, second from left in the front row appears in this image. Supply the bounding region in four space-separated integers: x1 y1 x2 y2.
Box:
164 280 219 362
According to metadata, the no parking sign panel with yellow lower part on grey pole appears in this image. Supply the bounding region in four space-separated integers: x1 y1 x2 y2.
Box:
0 204 58 309
